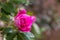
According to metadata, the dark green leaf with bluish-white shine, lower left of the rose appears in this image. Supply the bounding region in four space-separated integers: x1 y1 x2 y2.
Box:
3 28 16 40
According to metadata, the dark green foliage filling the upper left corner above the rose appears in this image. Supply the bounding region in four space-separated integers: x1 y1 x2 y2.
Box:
0 0 27 15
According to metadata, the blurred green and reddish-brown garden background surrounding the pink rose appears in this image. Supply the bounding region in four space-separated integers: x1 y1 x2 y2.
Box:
0 0 60 40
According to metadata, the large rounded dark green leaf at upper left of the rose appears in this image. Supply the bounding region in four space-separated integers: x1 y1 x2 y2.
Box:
2 3 15 13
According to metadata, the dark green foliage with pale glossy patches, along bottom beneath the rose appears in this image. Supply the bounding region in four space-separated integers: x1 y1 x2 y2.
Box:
3 28 34 40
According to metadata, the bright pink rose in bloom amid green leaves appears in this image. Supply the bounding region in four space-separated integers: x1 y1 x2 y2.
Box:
14 9 36 32
